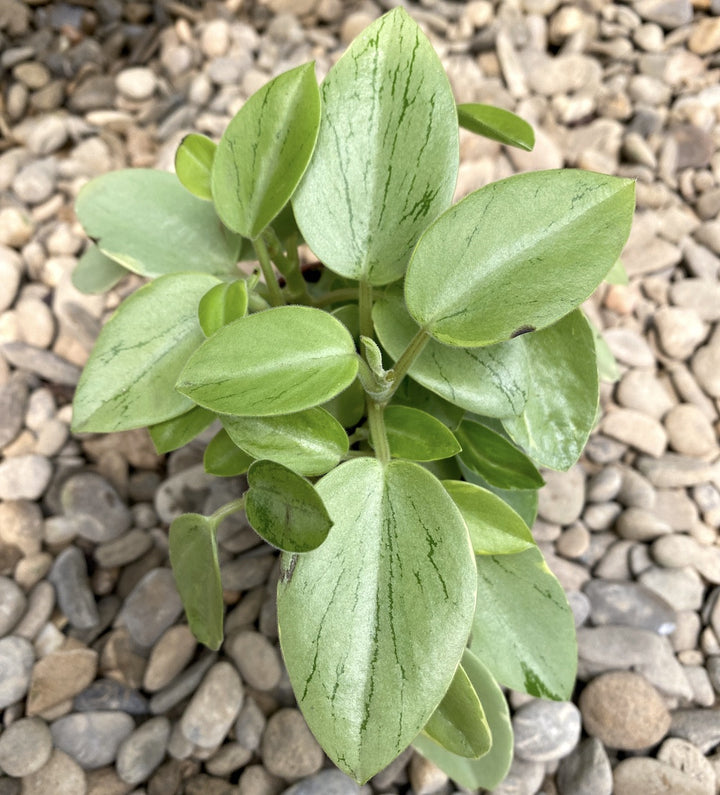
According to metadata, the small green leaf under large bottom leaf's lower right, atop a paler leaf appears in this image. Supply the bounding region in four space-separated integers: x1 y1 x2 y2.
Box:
423 663 492 759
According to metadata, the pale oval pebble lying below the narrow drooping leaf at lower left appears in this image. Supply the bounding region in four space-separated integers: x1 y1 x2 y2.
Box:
180 662 243 748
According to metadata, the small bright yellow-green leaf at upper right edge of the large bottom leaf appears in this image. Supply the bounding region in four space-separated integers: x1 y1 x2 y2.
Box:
443 480 535 555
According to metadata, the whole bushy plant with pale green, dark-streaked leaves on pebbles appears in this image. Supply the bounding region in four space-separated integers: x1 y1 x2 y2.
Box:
74 8 634 788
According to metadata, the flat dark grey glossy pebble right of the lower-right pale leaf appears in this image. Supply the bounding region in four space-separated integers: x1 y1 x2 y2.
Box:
584 580 675 635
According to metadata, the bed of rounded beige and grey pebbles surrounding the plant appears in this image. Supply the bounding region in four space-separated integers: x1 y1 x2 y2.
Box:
0 0 720 795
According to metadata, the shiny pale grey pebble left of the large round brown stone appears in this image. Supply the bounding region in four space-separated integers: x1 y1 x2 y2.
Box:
513 699 580 762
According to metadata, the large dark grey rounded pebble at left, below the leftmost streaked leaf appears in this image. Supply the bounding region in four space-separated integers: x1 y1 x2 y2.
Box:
60 472 132 544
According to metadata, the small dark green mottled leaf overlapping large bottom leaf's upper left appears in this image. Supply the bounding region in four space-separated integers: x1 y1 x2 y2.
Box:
245 461 332 552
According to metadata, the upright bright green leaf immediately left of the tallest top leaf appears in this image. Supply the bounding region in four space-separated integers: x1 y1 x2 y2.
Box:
212 63 320 240
